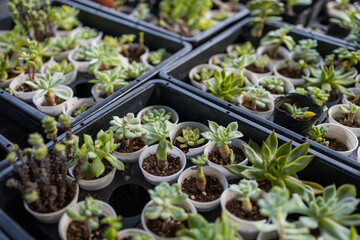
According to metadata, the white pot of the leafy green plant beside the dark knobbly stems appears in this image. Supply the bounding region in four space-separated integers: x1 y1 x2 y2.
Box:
69 166 116 191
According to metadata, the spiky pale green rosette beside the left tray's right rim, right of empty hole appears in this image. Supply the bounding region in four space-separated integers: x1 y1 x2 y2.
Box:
89 67 128 98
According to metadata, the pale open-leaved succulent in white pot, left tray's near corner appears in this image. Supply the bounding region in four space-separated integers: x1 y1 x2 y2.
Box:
25 72 73 116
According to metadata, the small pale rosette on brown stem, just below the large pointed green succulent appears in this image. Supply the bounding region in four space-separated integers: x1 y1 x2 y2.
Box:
230 179 261 212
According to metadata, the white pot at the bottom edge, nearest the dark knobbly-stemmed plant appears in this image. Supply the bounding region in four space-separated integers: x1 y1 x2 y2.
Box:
58 200 117 240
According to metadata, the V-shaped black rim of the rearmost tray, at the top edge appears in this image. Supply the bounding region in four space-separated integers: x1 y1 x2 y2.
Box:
74 0 249 46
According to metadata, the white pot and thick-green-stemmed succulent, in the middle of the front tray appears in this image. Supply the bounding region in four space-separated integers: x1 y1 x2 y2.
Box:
139 120 186 184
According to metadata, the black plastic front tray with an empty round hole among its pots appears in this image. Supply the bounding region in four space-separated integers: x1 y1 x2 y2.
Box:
0 80 360 240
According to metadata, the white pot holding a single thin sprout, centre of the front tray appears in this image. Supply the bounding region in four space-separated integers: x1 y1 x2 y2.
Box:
178 166 229 212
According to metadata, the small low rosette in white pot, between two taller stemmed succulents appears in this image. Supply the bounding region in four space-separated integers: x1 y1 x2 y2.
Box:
170 122 209 158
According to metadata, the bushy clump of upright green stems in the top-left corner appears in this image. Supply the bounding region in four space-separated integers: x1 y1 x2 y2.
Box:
8 0 55 42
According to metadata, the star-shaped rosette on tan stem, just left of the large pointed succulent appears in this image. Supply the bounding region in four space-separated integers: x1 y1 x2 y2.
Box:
201 121 243 163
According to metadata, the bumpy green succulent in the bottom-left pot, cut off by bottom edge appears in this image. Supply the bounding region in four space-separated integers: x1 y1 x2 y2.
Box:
66 196 122 240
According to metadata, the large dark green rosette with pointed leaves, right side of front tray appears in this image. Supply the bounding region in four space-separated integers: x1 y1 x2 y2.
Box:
225 132 323 195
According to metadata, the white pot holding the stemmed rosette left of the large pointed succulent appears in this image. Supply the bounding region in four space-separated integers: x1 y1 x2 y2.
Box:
204 139 248 179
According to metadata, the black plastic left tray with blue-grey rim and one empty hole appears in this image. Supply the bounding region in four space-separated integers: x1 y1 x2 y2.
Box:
0 0 191 130
